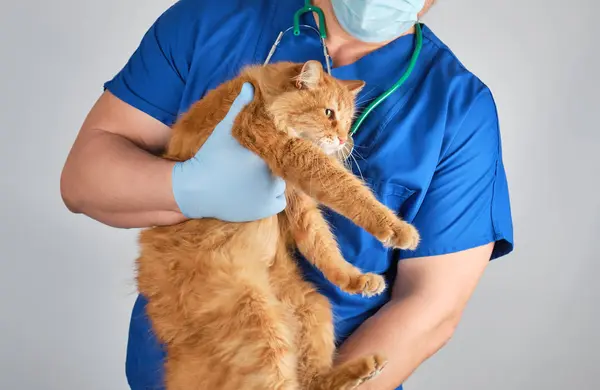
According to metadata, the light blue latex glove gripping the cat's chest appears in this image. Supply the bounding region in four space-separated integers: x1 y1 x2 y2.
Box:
173 83 286 222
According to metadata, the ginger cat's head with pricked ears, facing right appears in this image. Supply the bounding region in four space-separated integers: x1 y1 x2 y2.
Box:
268 61 365 155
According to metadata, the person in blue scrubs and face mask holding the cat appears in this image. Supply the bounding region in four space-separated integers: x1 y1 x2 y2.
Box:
61 0 513 390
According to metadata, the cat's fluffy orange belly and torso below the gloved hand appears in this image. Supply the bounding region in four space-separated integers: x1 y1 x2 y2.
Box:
138 217 304 390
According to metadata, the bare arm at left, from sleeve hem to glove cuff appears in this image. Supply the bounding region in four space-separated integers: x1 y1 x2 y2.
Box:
60 91 185 228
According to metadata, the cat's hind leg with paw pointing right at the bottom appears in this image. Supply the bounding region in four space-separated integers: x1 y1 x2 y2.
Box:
271 248 385 390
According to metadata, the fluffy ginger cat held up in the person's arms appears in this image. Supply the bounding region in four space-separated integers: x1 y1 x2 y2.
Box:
137 61 419 390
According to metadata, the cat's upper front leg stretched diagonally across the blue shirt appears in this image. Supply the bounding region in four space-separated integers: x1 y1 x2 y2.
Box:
232 116 419 249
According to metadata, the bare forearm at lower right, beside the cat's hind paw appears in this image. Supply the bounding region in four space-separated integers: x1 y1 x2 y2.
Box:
337 296 454 390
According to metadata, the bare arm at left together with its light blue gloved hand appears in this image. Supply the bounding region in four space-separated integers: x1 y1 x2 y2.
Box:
61 85 285 228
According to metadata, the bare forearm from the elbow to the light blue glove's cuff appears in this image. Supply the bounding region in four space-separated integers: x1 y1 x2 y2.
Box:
61 130 184 228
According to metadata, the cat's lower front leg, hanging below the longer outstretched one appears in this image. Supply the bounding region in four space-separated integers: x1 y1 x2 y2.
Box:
285 191 386 296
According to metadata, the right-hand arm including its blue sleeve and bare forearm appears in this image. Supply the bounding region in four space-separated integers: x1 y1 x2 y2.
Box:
341 80 512 390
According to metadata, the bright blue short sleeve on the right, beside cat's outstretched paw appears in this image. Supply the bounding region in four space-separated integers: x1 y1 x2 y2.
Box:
400 88 513 259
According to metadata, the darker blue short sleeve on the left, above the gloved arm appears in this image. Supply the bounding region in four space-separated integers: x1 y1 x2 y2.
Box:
104 0 195 126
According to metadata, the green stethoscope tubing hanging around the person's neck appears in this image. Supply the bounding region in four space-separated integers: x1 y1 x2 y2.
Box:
294 0 423 136
